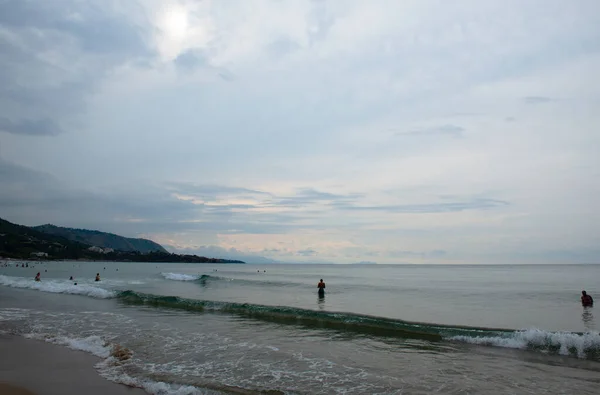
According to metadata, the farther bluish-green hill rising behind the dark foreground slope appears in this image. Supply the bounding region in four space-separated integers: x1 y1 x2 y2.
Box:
32 224 167 253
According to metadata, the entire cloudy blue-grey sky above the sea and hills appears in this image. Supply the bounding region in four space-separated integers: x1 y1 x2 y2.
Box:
0 0 600 264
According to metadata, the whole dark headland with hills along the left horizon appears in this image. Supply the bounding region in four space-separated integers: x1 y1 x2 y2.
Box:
0 218 244 263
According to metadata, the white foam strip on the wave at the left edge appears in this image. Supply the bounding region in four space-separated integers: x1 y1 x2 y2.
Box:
0 275 115 299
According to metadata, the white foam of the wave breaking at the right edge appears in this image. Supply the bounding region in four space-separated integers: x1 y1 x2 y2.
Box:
449 328 600 358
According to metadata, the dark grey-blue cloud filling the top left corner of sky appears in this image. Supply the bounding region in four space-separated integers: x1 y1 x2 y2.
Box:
0 0 154 136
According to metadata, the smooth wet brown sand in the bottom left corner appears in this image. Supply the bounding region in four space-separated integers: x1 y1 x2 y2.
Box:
0 335 146 395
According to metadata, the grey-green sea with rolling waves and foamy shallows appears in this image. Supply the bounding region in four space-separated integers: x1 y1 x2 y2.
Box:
0 262 600 395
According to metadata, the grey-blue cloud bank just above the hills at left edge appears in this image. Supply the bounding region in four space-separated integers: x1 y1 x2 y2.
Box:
0 158 202 233
